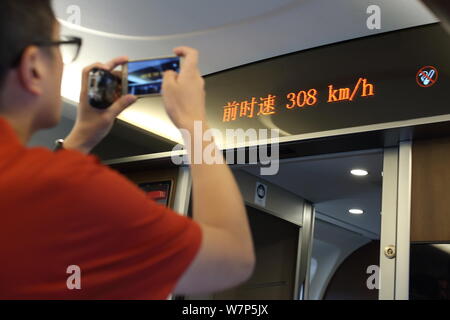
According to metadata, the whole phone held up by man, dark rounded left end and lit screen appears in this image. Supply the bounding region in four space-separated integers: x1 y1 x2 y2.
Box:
88 56 180 109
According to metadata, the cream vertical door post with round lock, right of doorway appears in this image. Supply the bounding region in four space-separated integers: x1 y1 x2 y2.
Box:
379 140 412 300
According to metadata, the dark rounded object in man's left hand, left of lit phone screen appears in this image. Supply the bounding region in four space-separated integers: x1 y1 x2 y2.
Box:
88 68 121 109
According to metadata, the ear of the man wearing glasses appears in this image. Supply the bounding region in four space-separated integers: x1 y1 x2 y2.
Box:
17 46 44 95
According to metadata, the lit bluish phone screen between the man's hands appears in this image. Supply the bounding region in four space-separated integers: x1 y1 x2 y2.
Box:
127 57 180 96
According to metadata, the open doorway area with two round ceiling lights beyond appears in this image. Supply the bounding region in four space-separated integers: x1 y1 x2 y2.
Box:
242 150 383 299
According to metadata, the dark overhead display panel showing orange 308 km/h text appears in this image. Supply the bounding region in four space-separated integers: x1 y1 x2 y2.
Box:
206 24 450 141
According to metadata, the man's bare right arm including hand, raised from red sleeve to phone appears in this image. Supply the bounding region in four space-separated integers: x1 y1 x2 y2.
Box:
163 47 255 294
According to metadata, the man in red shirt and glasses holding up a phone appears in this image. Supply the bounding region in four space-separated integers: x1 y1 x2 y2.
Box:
0 0 255 299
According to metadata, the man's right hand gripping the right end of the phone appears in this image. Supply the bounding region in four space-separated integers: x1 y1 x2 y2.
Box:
162 47 206 130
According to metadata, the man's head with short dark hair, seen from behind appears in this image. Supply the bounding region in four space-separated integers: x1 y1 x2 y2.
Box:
0 0 63 139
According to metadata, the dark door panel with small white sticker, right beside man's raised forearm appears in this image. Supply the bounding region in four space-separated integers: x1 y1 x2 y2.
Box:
184 167 313 300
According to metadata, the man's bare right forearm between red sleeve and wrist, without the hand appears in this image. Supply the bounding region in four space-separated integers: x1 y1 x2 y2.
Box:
175 125 255 294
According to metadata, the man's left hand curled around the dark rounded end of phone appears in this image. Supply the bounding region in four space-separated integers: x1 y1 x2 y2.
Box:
64 57 137 154
